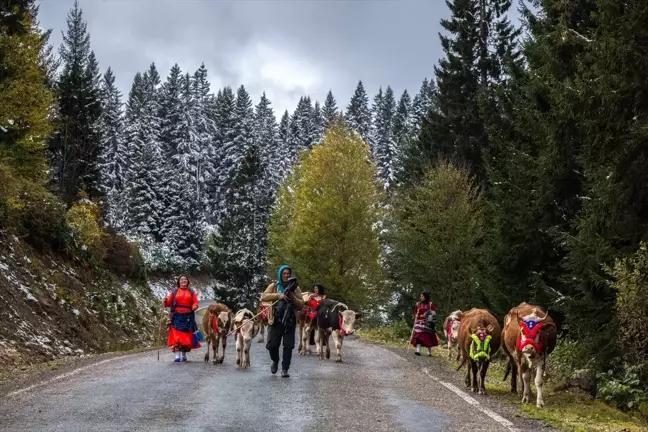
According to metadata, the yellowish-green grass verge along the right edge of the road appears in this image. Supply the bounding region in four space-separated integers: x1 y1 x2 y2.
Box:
356 328 648 432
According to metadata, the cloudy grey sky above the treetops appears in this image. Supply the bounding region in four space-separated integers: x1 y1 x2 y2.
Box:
39 0 520 115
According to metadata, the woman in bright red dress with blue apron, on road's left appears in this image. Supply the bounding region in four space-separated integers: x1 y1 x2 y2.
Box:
164 275 200 362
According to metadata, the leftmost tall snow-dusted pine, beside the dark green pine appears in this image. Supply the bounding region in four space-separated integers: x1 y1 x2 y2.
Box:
98 68 128 230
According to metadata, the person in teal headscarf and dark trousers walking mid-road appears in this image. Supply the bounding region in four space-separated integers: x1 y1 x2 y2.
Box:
261 265 304 378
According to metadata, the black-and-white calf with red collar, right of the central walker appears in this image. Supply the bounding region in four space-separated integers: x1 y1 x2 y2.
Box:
317 299 362 363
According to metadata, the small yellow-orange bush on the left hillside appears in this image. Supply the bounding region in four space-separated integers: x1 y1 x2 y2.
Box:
66 199 107 260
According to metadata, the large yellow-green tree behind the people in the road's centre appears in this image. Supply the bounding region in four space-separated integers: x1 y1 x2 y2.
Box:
269 124 381 308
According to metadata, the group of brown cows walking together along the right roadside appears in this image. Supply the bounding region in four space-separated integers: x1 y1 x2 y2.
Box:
443 303 558 408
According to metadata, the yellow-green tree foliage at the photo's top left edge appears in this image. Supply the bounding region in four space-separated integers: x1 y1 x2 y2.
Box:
0 5 53 184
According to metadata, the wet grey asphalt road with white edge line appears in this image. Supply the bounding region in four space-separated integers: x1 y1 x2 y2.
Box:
0 337 547 432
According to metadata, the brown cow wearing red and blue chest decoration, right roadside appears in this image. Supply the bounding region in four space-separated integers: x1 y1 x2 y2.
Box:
502 302 558 408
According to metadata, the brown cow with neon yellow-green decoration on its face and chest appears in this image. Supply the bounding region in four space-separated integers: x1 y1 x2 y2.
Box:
457 308 502 394
